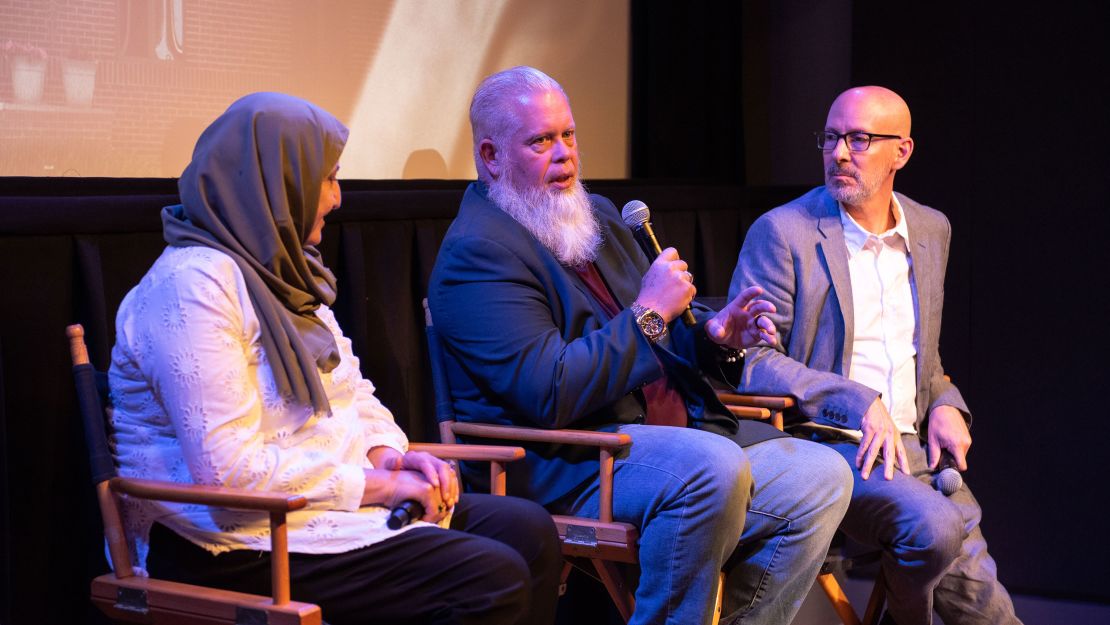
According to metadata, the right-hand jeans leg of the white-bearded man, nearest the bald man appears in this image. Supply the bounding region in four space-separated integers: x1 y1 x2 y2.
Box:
722 438 851 625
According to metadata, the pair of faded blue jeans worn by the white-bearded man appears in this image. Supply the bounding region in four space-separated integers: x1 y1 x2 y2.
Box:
557 425 851 625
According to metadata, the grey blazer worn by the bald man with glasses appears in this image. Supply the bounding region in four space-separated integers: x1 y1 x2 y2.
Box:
729 187 970 436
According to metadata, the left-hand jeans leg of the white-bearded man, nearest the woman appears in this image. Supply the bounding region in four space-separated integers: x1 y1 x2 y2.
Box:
559 425 751 625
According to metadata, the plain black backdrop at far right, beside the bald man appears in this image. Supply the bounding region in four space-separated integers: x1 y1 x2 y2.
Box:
851 2 1110 603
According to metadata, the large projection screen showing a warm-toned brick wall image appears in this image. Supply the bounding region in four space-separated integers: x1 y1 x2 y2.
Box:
0 0 628 179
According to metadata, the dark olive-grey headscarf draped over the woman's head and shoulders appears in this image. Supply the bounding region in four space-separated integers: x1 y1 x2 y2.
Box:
162 93 347 429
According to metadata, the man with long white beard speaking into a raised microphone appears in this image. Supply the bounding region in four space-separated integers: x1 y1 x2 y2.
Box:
428 68 850 625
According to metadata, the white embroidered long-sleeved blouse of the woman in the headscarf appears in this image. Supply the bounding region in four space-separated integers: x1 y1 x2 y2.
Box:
109 248 425 567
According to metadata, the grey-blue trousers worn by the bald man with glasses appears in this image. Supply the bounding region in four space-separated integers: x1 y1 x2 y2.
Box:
826 434 1020 625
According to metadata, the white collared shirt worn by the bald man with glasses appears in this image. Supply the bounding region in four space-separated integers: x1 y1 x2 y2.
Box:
840 196 917 434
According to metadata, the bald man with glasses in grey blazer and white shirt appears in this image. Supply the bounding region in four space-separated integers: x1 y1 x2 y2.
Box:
731 87 1019 625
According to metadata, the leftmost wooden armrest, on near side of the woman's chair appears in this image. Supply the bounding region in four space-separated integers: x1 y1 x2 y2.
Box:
109 477 309 512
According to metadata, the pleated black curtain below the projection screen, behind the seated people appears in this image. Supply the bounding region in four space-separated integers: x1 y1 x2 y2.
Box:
0 179 804 623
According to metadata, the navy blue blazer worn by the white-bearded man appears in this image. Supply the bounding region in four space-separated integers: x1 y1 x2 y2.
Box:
428 182 780 504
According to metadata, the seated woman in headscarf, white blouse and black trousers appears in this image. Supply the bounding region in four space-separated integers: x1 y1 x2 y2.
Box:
110 93 559 625
